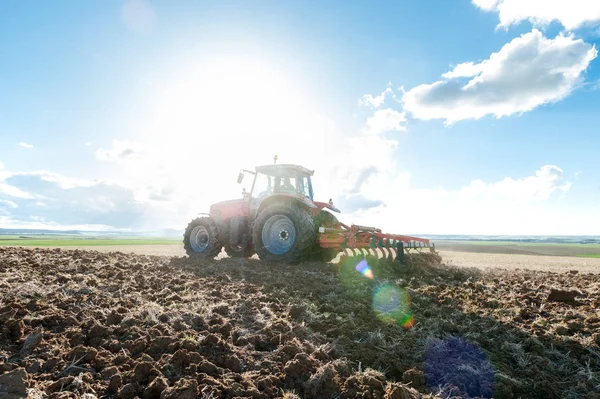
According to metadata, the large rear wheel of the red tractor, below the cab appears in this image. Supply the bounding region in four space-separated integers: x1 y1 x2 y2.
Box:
252 204 317 264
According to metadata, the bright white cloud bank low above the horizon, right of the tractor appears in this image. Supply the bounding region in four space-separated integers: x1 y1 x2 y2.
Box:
350 165 588 235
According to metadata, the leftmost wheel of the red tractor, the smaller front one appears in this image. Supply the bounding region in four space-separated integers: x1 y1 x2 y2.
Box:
183 216 223 259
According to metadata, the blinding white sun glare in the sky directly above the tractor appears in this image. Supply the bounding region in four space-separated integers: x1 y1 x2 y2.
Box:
126 56 335 219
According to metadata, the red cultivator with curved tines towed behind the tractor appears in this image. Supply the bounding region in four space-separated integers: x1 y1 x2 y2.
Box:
318 222 437 263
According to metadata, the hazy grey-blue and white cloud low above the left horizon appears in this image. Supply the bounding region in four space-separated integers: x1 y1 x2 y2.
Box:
0 171 189 230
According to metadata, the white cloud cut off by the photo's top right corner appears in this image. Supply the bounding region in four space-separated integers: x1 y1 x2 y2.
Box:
473 0 600 31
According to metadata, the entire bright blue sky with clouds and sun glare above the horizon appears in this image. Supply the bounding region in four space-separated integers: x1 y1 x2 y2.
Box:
0 0 600 235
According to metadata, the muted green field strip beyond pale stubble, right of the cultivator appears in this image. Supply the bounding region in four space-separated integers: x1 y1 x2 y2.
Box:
435 240 600 258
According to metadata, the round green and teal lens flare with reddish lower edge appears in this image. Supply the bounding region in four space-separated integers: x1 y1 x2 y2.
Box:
373 283 415 329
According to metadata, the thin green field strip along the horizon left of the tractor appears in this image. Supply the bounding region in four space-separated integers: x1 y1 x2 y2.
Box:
0 236 181 247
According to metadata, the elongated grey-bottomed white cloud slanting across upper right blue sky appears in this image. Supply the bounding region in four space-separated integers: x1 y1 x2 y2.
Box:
402 29 598 123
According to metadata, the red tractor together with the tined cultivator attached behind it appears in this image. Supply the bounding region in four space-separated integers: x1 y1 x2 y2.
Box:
183 164 435 264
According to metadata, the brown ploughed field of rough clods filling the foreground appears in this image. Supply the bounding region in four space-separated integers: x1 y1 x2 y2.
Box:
0 247 600 399
